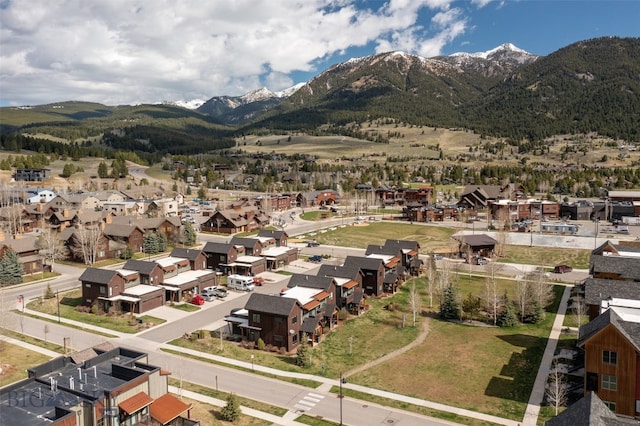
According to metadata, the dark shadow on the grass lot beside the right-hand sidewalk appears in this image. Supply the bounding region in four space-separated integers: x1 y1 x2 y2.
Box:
485 334 547 403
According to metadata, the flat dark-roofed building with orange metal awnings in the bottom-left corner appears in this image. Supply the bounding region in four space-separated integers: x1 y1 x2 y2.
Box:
0 343 199 426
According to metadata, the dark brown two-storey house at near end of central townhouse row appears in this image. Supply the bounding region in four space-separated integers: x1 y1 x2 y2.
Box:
241 293 303 352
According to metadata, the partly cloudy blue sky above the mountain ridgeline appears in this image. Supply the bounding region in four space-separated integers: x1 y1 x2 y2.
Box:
0 0 640 106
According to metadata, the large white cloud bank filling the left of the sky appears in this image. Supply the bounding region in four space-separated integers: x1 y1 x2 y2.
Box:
0 0 470 105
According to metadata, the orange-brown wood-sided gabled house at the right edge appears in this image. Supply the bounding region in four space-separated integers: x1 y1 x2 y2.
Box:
578 300 640 417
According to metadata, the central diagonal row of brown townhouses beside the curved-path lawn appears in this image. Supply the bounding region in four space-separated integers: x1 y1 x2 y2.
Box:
225 240 422 352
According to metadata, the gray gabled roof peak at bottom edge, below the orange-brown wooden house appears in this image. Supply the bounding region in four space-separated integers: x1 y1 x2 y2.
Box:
545 392 623 426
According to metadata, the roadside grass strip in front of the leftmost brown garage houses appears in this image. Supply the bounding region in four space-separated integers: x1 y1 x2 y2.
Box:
27 290 165 333
